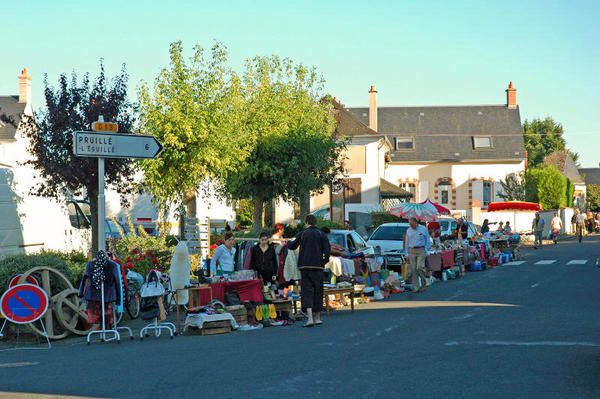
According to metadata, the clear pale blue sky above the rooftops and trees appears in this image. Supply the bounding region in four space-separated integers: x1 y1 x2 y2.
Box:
0 0 600 167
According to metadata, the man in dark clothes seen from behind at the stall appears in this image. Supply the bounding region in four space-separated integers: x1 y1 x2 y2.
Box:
288 215 331 327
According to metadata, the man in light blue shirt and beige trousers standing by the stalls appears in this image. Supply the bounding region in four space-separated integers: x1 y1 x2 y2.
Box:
404 218 431 292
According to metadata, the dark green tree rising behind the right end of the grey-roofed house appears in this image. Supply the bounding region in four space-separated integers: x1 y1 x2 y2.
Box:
523 117 566 168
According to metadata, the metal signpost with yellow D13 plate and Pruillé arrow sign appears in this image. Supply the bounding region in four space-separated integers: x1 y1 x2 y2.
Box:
73 115 163 343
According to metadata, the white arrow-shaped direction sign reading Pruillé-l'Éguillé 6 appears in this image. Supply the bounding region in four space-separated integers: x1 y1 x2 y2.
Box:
73 133 163 159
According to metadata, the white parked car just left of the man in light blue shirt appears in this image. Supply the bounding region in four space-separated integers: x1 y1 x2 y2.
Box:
367 223 410 269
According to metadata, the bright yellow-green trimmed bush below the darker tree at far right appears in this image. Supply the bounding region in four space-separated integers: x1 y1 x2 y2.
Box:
525 166 567 209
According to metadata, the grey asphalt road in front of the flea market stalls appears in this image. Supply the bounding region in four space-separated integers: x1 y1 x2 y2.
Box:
0 237 600 399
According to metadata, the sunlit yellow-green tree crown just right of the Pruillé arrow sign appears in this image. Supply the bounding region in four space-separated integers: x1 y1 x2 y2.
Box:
139 42 248 231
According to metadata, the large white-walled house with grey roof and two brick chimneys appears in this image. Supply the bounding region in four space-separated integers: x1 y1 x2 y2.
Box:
347 82 526 216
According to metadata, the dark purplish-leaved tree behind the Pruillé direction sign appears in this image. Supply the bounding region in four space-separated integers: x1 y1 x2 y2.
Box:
23 61 135 253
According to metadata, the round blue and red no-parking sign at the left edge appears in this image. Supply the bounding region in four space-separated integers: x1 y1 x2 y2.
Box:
0 284 48 324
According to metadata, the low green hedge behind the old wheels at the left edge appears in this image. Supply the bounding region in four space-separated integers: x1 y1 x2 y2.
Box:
0 253 79 292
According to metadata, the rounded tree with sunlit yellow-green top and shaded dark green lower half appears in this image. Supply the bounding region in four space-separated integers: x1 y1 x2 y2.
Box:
223 56 341 231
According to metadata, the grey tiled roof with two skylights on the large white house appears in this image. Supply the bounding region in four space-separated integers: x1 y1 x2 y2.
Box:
348 105 525 162
